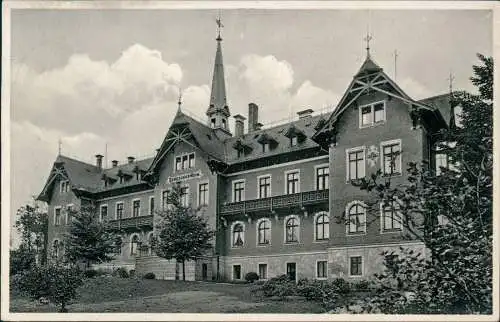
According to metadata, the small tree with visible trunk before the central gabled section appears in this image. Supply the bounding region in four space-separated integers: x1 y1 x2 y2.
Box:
153 185 214 280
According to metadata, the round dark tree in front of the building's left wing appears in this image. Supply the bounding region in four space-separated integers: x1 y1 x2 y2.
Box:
65 205 116 268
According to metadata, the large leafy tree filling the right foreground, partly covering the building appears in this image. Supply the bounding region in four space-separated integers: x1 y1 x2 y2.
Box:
354 55 493 314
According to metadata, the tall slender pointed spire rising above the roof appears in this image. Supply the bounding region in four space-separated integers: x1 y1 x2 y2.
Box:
207 16 230 117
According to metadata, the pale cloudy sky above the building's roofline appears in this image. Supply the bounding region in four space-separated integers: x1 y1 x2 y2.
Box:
6 9 492 244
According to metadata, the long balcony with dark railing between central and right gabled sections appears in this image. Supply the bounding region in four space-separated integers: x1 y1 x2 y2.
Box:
220 189 329 215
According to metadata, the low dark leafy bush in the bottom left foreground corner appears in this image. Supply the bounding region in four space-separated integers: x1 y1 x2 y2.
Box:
18 264 83 312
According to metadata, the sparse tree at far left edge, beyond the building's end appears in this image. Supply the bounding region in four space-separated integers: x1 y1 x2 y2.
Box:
14 203 48 263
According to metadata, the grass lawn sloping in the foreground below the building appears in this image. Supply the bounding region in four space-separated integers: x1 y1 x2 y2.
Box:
10 277 323 313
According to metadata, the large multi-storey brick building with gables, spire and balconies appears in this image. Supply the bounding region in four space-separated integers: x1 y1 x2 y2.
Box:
38 27 453 280
